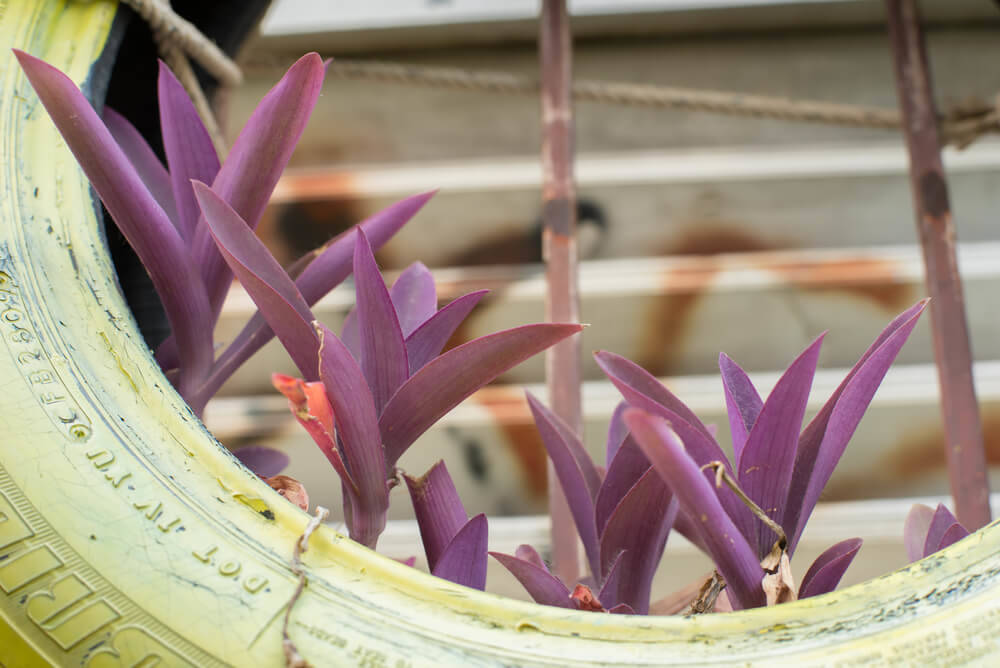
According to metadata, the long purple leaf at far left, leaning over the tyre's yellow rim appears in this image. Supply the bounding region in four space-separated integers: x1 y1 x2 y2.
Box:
14 49 212 394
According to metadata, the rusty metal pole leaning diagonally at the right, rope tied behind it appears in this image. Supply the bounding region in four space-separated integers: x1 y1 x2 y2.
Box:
886 0 990 529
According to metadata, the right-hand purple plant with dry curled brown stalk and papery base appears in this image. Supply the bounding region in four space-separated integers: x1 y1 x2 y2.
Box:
596 301 926 609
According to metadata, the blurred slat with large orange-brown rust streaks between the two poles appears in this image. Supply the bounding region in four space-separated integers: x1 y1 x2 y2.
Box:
216 243 1000 394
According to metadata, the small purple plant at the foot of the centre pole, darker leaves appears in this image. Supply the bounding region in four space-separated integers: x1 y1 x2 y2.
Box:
490 394 678 615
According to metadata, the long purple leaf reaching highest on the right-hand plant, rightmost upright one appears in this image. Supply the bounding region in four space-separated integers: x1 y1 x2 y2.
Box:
779 300 927 554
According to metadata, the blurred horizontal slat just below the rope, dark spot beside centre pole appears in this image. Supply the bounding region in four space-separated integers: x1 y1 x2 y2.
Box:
259 142 1000 267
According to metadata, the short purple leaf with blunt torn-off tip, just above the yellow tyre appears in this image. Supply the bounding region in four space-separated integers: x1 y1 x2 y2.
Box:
403 461 469 571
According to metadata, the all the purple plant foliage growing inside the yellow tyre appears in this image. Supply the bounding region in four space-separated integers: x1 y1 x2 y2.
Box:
15 50 936 614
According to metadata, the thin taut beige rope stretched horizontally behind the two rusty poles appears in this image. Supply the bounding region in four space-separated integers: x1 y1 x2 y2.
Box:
327 60 1000 148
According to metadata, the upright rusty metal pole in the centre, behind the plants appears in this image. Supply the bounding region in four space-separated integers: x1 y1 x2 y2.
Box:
538 0 583 584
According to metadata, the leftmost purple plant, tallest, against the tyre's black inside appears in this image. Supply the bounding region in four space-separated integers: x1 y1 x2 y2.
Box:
14 49 431 415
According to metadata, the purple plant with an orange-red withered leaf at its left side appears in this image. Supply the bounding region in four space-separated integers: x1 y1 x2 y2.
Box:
194 182 581 548
